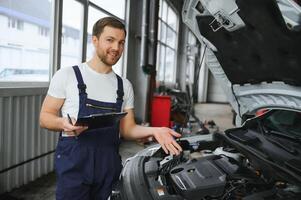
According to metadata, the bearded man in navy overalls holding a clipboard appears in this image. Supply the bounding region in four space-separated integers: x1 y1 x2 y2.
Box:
40 17 182 200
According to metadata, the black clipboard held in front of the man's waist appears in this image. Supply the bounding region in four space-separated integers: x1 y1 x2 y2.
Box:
75 112 127 130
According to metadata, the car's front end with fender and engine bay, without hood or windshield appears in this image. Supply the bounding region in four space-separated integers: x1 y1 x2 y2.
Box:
117 110 301 200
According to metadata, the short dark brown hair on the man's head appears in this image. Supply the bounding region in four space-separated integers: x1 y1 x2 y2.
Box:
92 17 126 37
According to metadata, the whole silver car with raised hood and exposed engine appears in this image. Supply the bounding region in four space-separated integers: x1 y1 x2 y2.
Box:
112 0 301 200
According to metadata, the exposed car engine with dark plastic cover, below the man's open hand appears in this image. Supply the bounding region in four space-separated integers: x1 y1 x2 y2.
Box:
141 137 301 200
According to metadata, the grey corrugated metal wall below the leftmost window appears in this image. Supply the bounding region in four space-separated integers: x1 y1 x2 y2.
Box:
0 88 58 194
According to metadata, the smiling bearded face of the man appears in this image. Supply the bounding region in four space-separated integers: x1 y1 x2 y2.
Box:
92 26 125 67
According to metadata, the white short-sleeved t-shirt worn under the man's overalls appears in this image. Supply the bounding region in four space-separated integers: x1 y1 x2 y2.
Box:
48 63 134 119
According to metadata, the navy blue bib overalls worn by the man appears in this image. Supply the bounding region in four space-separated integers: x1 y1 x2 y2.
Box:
55 66 124 200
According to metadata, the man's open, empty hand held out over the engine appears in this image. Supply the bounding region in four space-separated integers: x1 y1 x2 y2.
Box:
153 127 182 155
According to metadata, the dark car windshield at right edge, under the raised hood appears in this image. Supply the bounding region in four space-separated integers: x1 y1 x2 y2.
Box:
262 110 301 138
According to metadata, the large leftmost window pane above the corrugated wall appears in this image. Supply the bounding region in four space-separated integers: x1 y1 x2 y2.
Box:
0 0 52 83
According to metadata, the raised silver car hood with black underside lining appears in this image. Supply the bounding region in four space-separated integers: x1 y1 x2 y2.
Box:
182 0 301 123
